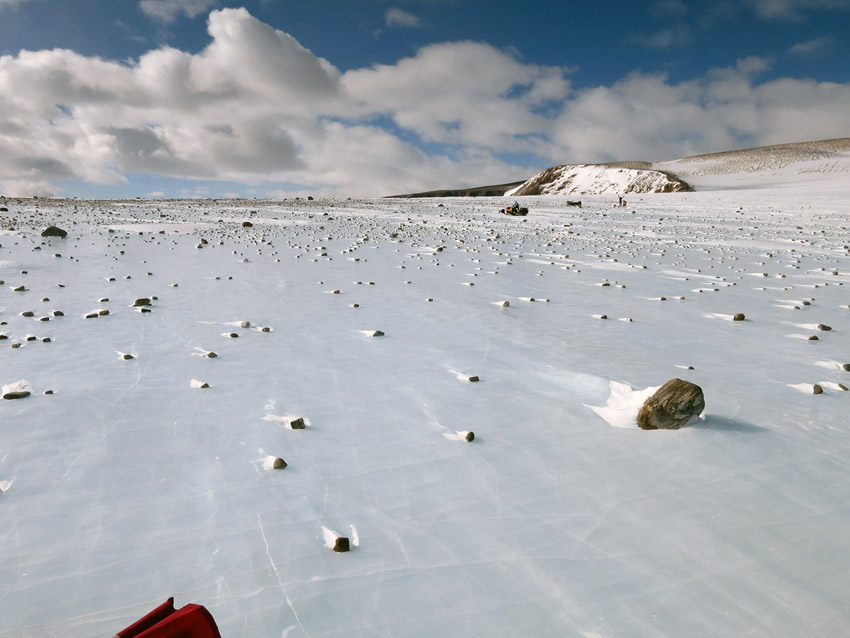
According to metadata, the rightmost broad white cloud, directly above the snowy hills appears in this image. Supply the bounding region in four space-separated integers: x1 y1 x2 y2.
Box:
551 58 850 161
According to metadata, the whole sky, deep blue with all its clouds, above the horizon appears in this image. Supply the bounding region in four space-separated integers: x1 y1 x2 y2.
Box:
0 0 850 197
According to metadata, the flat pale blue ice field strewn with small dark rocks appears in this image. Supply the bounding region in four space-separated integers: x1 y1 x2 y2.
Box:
0 173 850 638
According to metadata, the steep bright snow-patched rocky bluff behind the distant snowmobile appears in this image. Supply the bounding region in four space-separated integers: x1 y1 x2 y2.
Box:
506 164 691 196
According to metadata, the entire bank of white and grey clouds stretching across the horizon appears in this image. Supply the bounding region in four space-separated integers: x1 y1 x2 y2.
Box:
0 6 850 196
